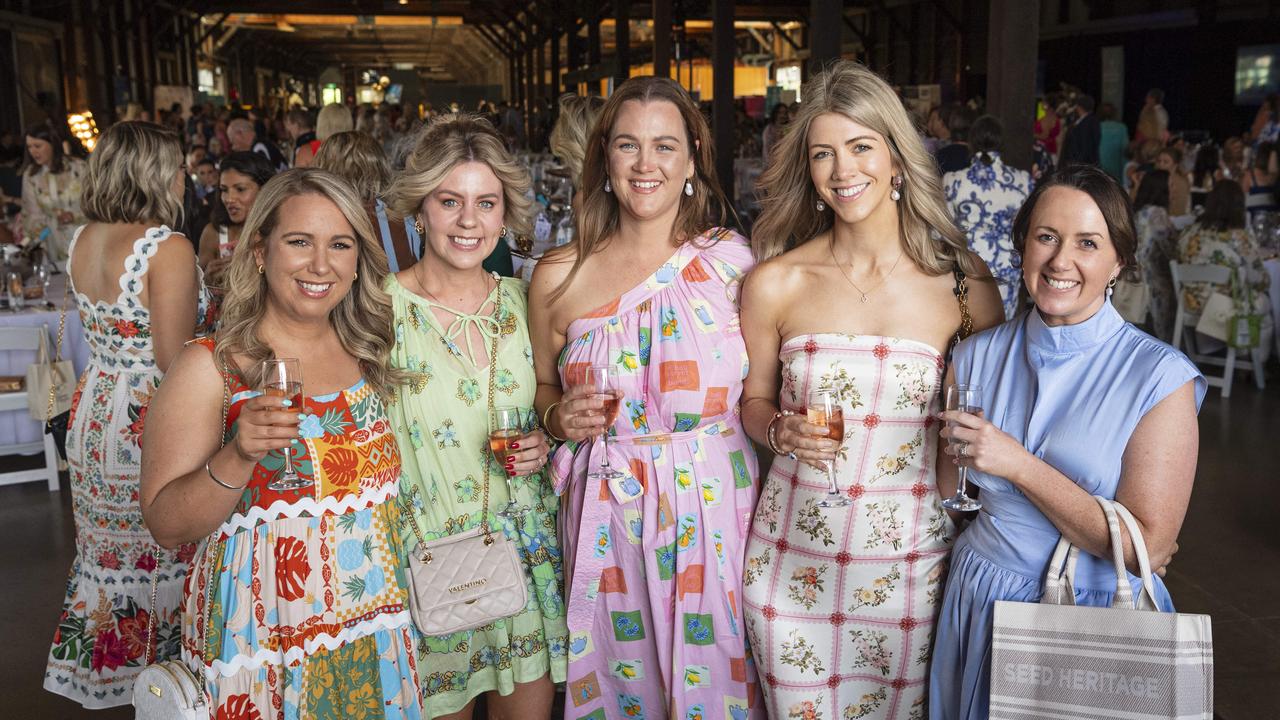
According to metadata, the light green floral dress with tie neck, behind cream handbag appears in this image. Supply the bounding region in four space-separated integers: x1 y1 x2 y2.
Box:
387 275 568 717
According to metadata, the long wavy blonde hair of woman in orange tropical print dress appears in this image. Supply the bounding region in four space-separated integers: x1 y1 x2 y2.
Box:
214 168 403 400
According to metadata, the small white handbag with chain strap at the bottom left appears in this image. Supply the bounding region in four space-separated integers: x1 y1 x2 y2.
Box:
133 365 230 720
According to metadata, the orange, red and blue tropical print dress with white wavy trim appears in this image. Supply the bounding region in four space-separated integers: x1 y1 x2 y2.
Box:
182 338 421 720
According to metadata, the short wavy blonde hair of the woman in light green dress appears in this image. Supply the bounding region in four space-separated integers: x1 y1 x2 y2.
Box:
386 113 534 234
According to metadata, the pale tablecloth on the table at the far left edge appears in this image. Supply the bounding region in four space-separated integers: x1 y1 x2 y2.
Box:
0 274 88 446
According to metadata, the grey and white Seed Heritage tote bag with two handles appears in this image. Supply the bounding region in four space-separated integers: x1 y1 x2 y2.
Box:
989 497 1213 720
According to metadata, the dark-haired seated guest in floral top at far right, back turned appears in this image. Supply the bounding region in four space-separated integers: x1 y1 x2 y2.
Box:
1178 179 1272 354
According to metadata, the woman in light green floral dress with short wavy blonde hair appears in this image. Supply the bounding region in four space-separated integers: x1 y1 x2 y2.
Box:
387 115 568 719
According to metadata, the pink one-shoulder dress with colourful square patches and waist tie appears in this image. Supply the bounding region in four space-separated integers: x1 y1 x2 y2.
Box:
553 231 764 720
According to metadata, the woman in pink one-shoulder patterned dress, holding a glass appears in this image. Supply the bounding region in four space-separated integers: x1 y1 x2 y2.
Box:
529 77 763 720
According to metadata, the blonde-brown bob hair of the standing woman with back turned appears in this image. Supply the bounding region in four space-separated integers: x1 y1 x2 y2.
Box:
81 120 183 227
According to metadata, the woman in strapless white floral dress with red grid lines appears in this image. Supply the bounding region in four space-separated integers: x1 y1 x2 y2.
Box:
742 63 1004 720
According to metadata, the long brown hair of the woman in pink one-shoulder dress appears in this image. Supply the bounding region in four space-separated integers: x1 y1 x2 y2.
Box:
550 76 731 301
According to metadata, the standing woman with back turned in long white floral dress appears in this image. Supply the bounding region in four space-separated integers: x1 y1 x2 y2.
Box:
45 122 209 708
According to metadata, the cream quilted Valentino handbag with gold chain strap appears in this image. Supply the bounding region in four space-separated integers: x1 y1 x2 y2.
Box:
408 278 529 635
